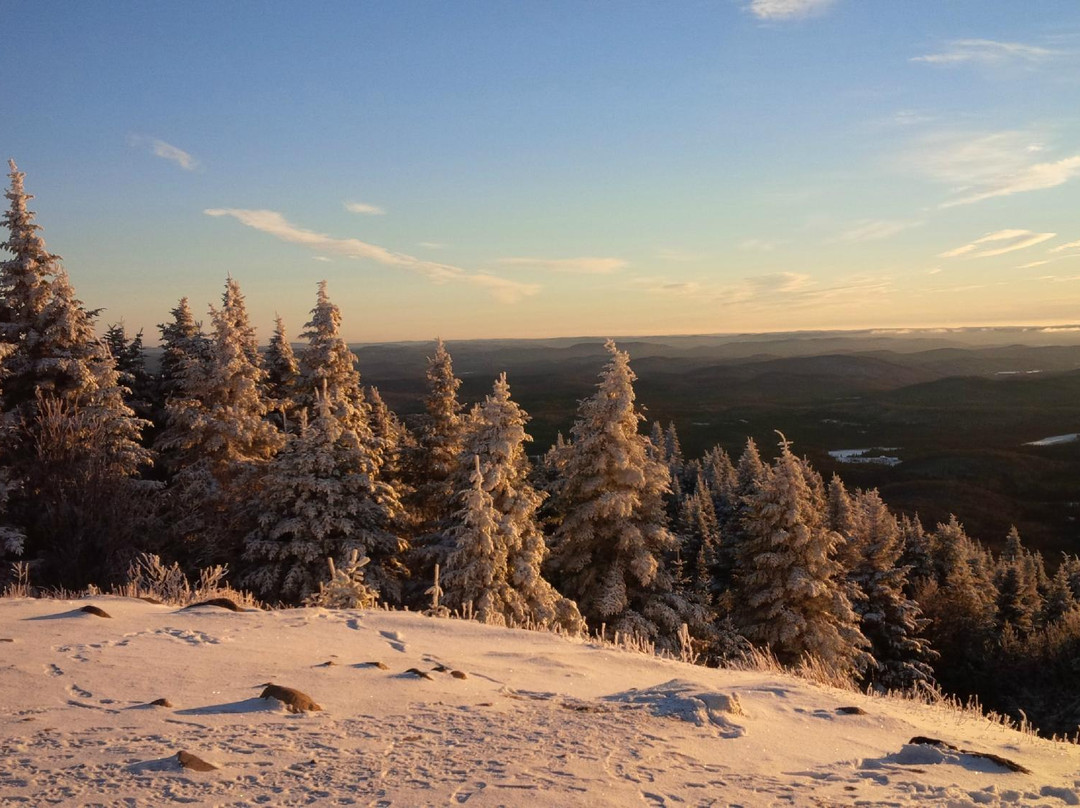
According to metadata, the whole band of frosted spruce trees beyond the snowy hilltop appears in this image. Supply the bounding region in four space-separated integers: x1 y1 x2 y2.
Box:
6 163 1080 733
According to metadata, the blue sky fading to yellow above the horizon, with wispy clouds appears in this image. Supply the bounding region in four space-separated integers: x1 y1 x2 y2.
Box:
6 0 1080 344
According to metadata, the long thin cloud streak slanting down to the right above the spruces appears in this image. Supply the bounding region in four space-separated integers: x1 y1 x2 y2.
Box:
203 207 540 302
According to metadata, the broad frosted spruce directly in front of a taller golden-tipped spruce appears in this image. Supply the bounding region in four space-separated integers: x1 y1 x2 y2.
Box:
243 398 403 604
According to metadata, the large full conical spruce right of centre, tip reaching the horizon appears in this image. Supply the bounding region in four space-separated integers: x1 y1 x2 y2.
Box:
552 340 686 647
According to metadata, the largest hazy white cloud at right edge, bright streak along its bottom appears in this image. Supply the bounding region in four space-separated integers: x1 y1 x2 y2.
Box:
904 131 1080 208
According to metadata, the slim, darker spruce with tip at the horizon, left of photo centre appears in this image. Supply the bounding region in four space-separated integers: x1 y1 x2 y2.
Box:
410 339 463 533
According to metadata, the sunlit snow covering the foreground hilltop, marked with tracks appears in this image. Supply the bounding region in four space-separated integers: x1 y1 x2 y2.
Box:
0 597 1080 807
